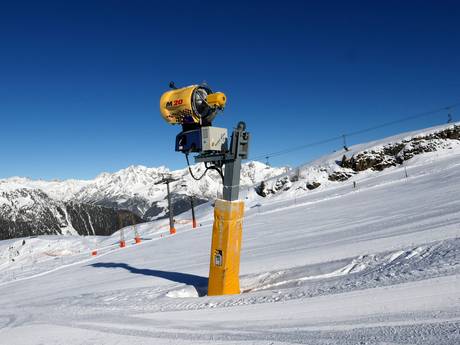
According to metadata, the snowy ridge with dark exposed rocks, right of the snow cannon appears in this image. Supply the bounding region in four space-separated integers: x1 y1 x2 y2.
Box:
256 124 460 197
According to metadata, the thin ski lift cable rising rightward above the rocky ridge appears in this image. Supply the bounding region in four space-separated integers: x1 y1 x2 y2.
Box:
251 102 460 160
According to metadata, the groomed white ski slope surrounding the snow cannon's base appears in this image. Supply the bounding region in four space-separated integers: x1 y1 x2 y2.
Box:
0 122 460 345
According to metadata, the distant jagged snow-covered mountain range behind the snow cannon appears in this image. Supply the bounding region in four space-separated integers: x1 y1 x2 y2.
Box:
0 162 287 239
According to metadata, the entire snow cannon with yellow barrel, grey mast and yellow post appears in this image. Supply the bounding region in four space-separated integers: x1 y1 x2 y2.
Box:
160 82 250 295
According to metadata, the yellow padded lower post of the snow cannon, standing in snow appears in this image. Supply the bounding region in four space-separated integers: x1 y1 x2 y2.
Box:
208 199 244 296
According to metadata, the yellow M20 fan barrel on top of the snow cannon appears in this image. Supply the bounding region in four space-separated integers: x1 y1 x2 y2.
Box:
160 85 227 126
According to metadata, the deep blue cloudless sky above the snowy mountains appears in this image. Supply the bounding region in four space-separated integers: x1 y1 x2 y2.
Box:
0 0 460 179
